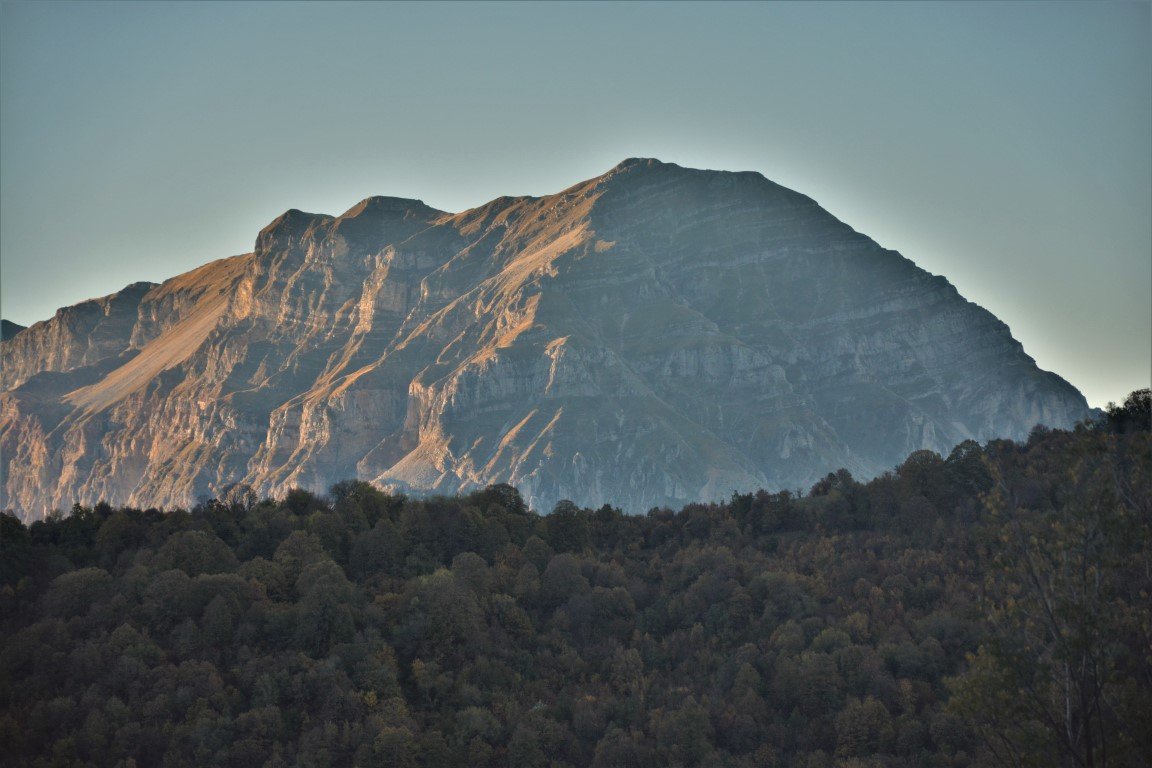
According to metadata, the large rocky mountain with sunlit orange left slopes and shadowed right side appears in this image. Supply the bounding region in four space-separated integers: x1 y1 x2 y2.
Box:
0 159 1089 518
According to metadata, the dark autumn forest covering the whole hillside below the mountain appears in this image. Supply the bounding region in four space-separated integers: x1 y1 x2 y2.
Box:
0 390 1152 768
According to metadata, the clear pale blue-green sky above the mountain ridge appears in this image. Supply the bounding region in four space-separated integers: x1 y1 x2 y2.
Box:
0 2 1152 405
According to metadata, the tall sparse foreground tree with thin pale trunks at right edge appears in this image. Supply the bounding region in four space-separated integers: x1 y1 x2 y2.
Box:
950 433 1152 768
